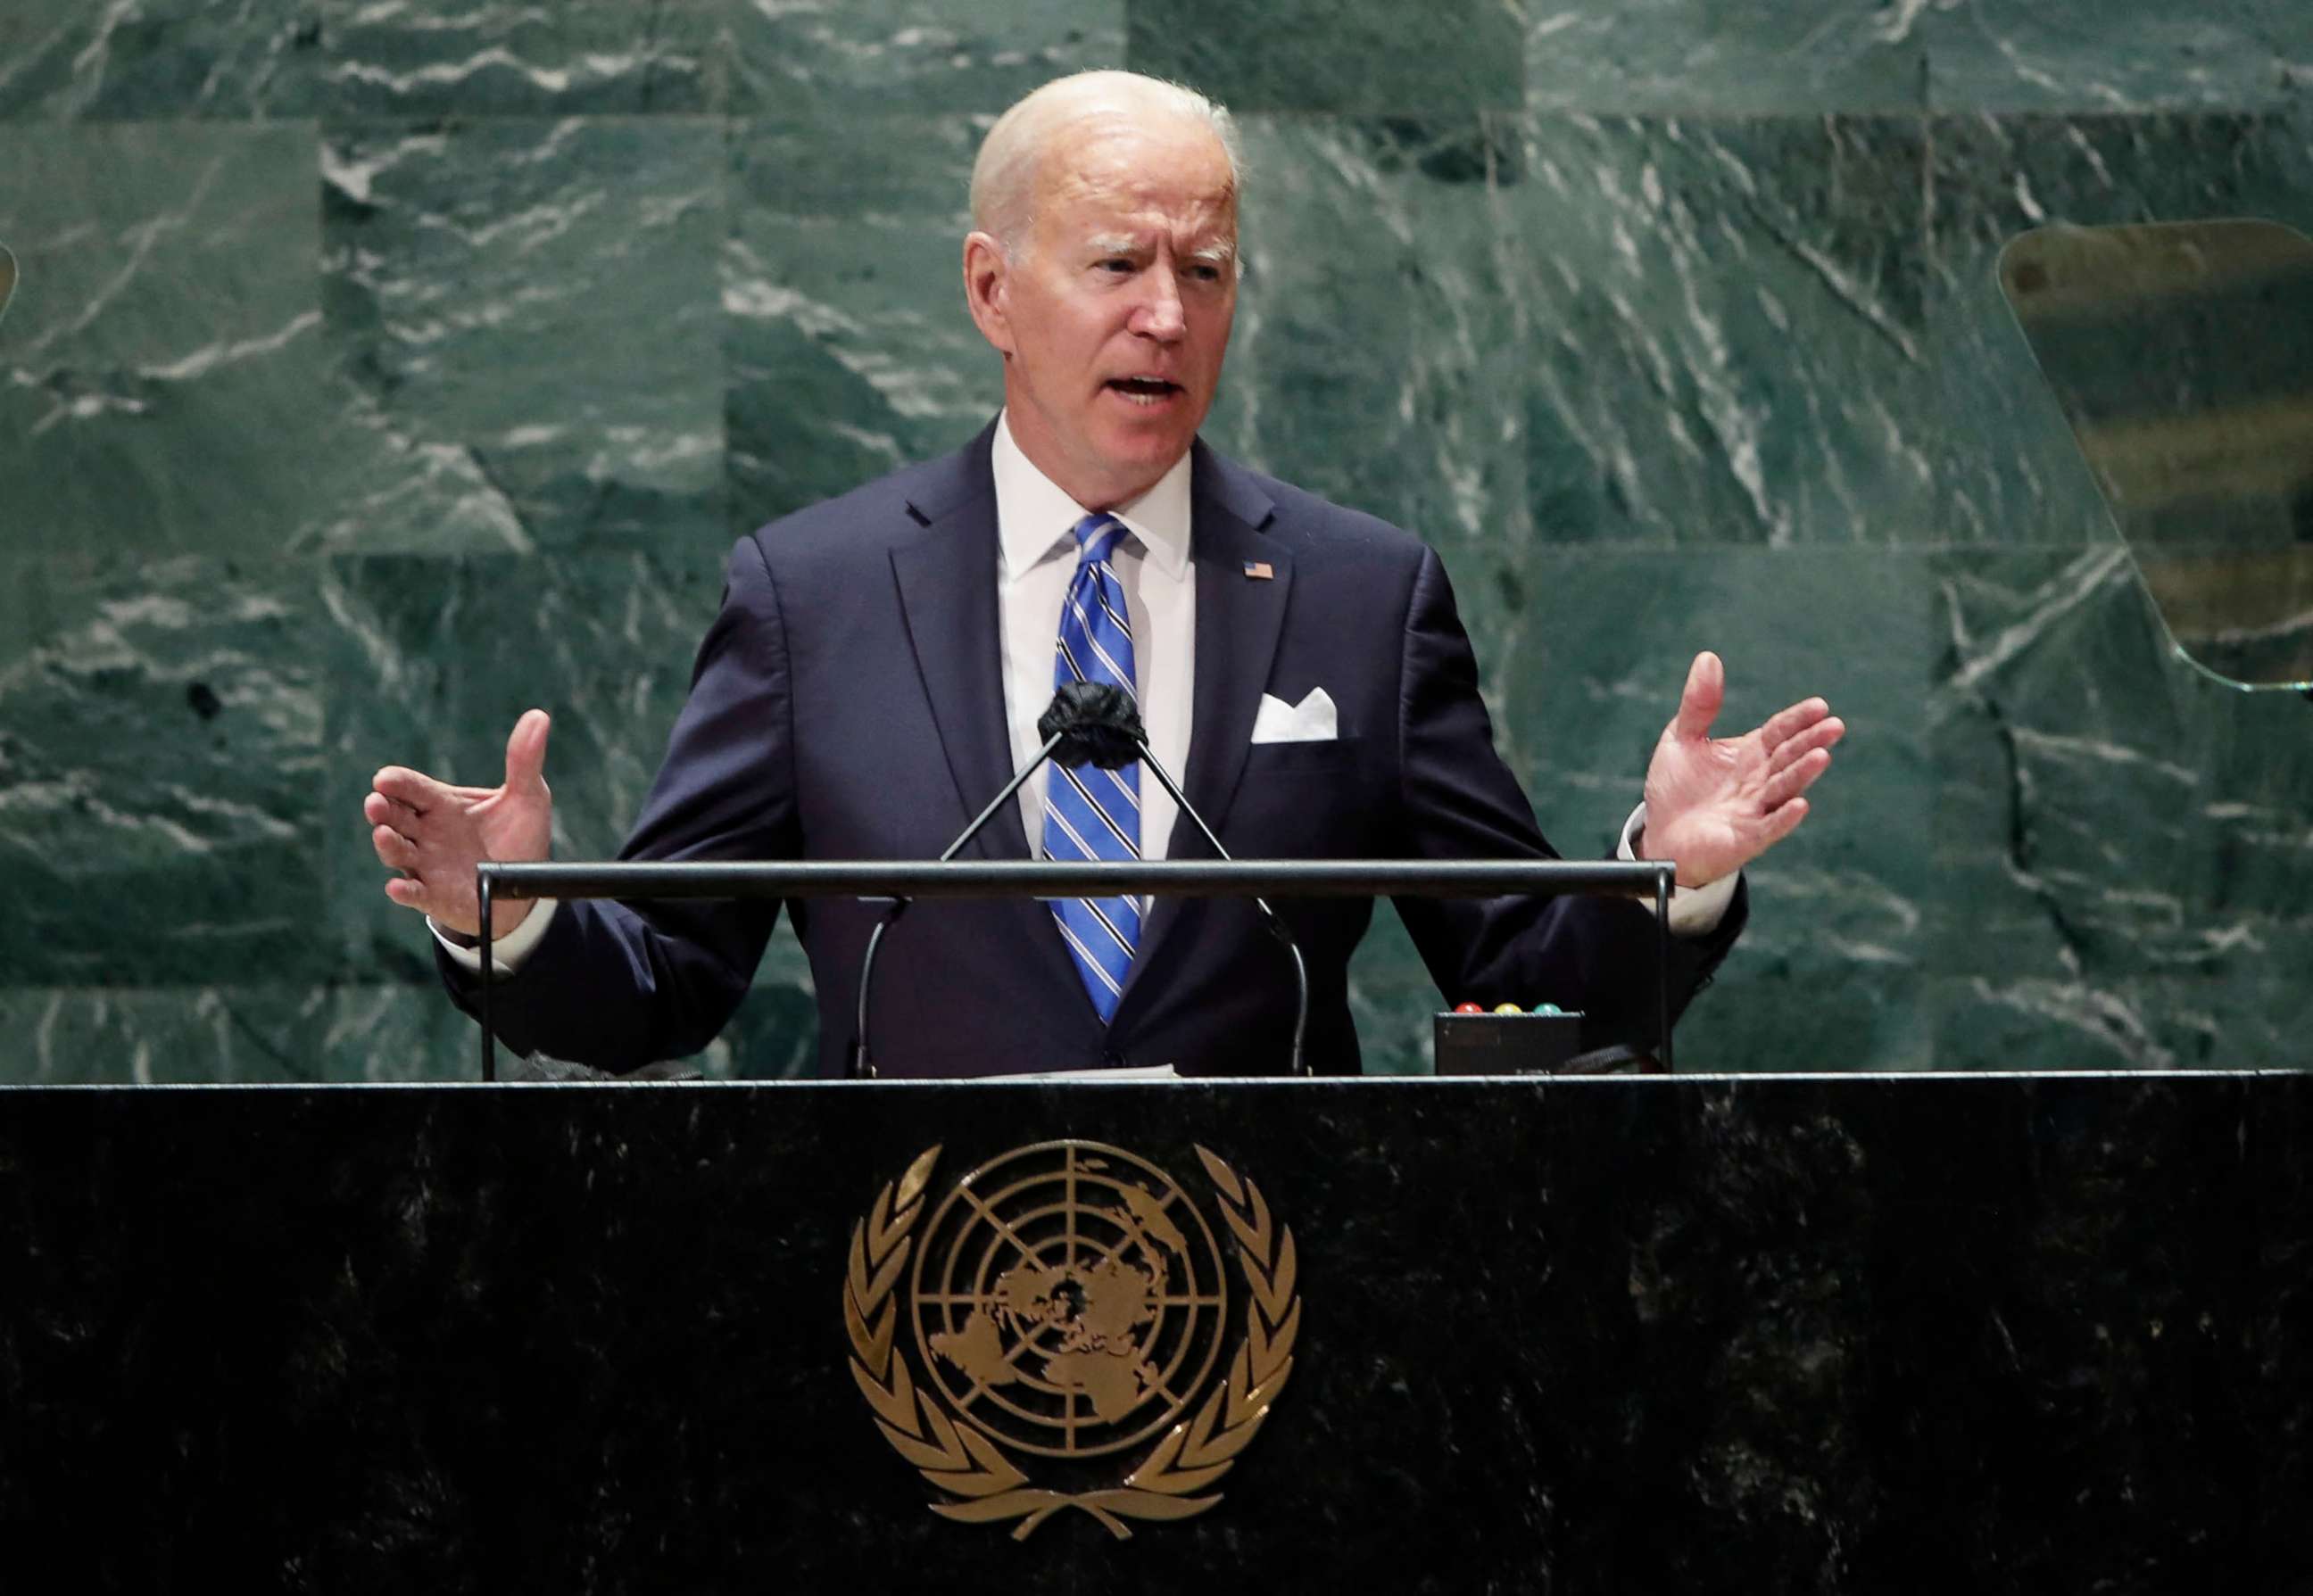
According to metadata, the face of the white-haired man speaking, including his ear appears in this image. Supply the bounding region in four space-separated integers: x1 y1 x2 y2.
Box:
965 118 1238 509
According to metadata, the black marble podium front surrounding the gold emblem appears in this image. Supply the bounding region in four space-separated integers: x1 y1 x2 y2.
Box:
0 1073 2313 1593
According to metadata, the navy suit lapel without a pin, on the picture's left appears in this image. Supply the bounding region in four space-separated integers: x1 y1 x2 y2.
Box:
891 428 1026 856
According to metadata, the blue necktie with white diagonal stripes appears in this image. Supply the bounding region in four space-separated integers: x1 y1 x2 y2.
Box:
1043 516 1140 1025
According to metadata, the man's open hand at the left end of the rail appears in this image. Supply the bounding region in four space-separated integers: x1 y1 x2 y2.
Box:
361 710 555 937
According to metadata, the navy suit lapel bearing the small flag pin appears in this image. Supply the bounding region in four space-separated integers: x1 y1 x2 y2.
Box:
1117 444 1293 1020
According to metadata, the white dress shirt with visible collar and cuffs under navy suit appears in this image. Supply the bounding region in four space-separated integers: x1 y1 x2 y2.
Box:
428 417 1739 974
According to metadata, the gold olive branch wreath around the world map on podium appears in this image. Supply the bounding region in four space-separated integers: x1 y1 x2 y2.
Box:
844 1147 1300 1541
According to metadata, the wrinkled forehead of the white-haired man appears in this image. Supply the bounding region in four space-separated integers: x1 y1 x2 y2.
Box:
1036 113 1238 238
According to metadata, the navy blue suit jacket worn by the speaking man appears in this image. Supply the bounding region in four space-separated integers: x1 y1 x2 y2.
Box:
442 428 1744 1076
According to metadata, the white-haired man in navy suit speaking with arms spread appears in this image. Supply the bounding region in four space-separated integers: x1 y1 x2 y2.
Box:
366 71 1841 1076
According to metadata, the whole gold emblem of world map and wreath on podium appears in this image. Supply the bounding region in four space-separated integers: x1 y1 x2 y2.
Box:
844 1140 1300 1541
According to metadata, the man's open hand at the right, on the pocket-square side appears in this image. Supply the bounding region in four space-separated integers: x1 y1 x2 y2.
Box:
1637 652 1848 886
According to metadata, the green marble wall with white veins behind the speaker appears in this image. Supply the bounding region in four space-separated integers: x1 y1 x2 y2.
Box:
0 0 2313 1080
